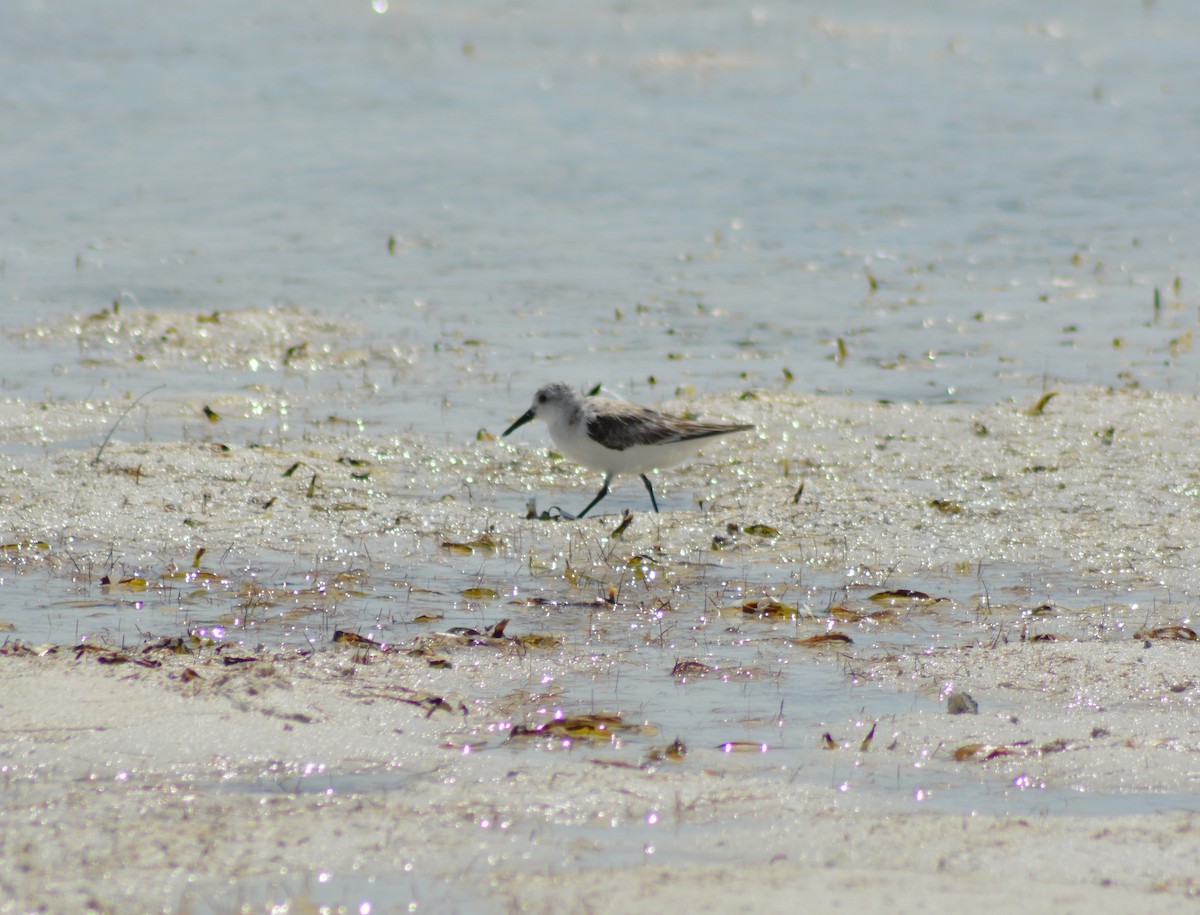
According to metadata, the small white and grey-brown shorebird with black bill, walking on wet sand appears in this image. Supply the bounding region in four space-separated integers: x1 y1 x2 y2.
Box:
504 382 754 518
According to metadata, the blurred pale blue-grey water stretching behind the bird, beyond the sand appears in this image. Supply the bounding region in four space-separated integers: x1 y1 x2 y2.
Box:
0 0 1200 437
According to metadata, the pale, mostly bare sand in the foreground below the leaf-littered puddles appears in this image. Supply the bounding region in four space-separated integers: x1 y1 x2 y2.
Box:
0 652 1200 913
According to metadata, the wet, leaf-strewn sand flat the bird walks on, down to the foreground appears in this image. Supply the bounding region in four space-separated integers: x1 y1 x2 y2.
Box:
0 360 1200 913
